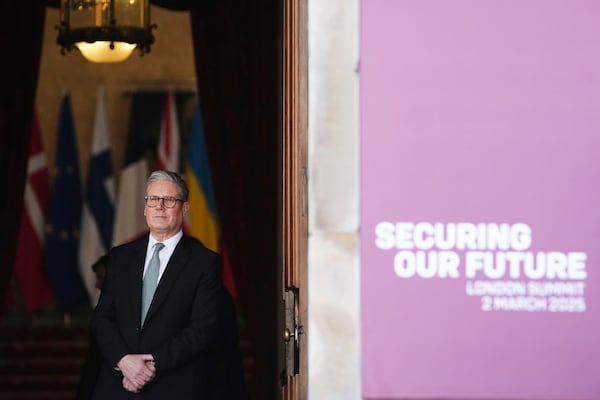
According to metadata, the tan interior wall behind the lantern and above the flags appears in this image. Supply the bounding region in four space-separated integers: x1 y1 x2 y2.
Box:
35 6 196 182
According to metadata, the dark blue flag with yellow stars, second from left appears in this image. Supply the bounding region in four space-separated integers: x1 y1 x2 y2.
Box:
44 92 87 311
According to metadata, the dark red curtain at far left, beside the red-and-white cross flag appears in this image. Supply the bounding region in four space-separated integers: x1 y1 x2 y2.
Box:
0 1 46 315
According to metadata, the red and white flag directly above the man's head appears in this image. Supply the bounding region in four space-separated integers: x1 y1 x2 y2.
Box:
156 90 181 172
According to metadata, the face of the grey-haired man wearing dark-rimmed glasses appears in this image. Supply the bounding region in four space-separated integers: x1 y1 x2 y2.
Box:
144 181 190 240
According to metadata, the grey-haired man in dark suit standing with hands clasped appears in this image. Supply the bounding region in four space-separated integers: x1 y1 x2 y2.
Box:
92 171 226 400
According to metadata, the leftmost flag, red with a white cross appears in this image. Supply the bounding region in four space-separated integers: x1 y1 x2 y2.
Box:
14 112 54 312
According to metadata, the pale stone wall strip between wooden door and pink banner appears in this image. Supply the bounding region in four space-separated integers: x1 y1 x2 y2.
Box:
308 0 361 400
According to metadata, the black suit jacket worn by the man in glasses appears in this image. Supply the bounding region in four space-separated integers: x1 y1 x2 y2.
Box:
92 235 225 400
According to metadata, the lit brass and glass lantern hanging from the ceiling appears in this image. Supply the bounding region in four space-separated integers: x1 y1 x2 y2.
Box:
56 0 156 63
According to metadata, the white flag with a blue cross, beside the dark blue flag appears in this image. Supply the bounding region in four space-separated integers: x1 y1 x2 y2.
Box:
79 88 115 305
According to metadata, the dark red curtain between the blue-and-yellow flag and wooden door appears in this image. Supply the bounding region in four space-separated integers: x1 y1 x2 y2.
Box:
191 1 281 399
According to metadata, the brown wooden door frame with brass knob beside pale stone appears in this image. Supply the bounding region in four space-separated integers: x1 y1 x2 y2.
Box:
280 0 309 400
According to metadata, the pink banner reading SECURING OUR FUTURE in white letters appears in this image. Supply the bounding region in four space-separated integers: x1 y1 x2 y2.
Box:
360 0 600 400
